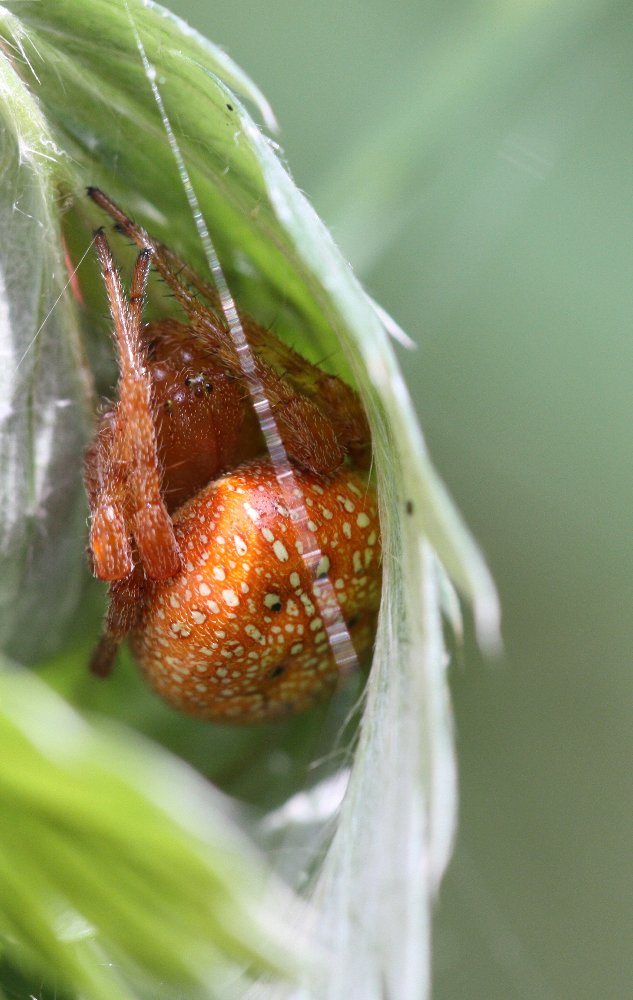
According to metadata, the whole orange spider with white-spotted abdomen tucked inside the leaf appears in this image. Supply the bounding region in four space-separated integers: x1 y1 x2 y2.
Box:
85 188 380 722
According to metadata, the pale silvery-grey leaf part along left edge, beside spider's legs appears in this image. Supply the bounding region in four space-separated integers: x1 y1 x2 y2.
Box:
0 19 89 660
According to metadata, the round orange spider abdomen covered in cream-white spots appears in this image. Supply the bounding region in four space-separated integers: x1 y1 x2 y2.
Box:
133 459 380 722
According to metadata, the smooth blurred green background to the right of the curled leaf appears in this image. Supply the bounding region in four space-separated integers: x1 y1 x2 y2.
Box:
164 0 633 1000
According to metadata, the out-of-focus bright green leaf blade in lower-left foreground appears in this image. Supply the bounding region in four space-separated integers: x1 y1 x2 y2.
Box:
0 669 306 996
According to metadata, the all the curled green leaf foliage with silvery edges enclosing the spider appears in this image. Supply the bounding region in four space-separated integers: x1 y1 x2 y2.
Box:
0 0 498 1000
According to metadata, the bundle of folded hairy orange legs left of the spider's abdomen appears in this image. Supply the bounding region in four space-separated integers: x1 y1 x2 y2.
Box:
86 232 180 675
